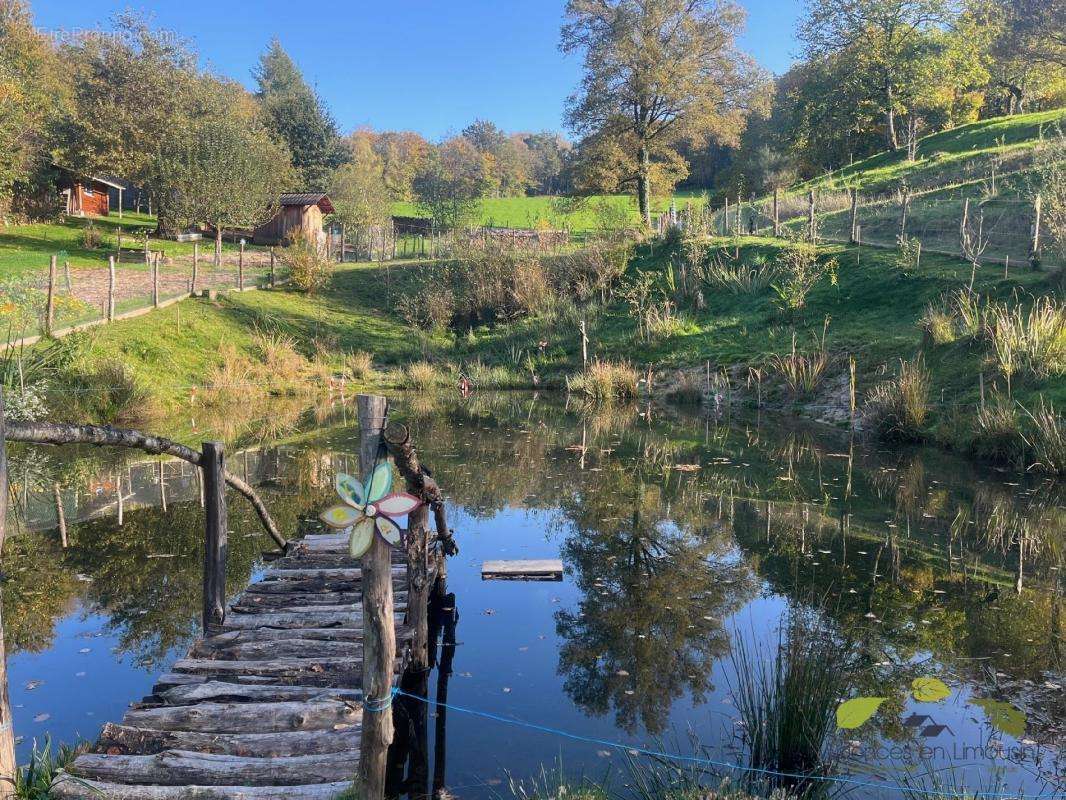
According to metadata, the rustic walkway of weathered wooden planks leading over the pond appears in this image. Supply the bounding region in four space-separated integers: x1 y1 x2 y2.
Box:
52 534 409 800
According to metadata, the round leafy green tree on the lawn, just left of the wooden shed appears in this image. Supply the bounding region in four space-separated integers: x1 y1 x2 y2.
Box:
166 86 292 266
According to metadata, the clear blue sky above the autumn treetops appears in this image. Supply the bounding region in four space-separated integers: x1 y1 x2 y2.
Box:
31 0 801 140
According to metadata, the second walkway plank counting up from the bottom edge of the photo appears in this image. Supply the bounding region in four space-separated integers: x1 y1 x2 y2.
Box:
67 750 359 786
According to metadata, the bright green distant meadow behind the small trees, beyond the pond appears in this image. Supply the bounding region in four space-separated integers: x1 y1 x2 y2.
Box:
392 192 706 234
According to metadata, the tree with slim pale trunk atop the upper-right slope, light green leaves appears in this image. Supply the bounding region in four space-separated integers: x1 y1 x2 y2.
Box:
798 0 950 150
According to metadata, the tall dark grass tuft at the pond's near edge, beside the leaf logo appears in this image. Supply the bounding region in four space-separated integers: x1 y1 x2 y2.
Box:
729 610 853 795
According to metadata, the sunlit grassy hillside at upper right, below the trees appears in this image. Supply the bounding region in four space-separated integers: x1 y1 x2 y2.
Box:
790 109 1066 192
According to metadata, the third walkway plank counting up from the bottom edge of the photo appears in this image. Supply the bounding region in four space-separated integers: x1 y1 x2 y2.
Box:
94 722 360 758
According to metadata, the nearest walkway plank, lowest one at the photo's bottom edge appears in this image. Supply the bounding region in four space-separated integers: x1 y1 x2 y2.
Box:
51 774 352 800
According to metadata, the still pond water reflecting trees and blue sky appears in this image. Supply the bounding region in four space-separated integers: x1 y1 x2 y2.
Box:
2 393 1066 798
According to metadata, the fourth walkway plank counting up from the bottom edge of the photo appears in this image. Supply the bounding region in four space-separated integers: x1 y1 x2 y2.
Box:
123 700 362 733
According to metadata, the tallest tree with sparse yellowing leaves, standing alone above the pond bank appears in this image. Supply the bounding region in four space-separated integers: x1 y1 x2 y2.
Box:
561 0 748 224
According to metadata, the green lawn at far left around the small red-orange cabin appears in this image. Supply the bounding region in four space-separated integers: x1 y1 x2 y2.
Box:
0 211 260 279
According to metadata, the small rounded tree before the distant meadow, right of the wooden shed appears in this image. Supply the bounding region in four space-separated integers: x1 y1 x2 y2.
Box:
413 137 488 229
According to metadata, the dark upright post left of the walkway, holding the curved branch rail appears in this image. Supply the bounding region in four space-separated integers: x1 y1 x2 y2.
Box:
200 442 229 636
